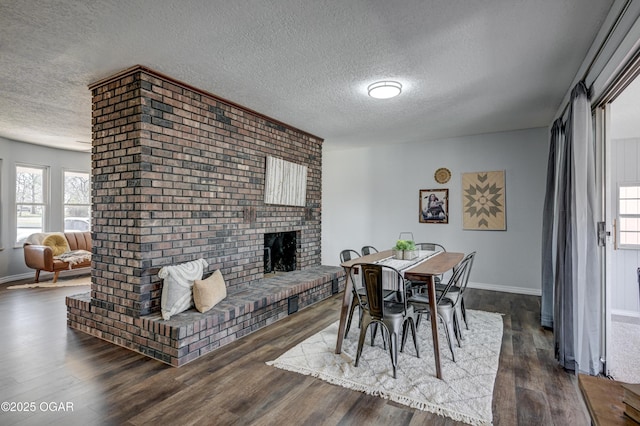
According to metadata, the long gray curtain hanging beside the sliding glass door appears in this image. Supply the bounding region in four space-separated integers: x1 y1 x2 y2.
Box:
541 82 602 375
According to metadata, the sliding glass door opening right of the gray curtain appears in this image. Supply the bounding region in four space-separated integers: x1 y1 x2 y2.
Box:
596 78 640 383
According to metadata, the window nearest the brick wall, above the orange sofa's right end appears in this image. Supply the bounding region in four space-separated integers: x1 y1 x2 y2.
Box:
64 170 91 232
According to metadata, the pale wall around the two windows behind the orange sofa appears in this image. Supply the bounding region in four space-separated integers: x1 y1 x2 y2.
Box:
0 138 91 283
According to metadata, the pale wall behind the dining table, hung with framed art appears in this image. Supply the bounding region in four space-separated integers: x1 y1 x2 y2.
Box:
322 128 549 295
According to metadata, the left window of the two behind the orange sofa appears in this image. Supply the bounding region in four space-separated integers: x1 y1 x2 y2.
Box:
16 166 47 244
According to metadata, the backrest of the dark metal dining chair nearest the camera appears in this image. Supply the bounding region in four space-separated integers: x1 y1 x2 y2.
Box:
351 263 407 319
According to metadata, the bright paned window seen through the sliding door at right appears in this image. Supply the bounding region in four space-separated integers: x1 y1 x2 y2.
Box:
618 183 640 248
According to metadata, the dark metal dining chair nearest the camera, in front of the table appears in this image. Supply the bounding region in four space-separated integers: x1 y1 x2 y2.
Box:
351 263 420 379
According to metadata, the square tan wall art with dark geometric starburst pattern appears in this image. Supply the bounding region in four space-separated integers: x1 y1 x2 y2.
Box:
462 171 507 231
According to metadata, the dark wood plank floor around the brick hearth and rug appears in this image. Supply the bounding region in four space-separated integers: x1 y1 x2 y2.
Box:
0 276 589 425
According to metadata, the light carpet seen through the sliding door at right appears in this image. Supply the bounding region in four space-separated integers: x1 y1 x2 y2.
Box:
609 318 640 383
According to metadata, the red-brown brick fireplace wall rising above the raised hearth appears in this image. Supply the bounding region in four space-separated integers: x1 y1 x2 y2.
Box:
90 67 322 318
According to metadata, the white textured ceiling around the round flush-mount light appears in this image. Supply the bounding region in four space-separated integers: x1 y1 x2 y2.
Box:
0 0 613 150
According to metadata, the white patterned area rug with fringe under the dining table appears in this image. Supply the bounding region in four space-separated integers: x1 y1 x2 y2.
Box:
267 310 503 425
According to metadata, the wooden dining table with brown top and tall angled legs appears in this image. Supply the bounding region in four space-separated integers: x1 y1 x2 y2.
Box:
336 250 464 379
